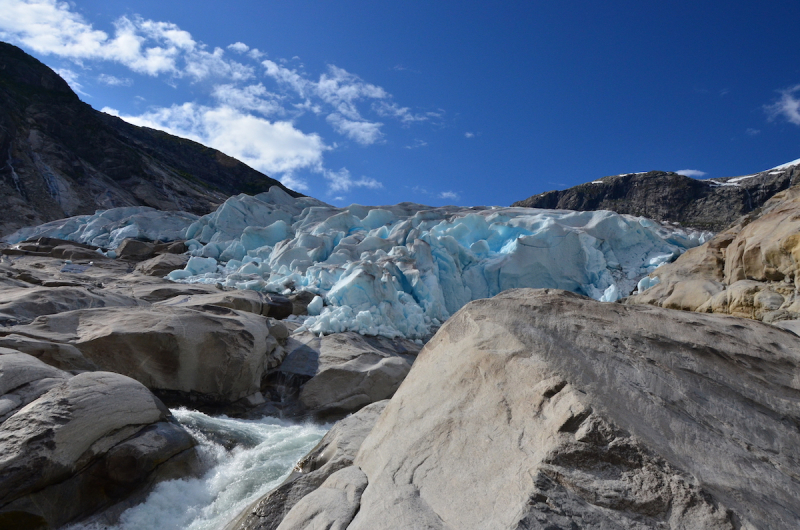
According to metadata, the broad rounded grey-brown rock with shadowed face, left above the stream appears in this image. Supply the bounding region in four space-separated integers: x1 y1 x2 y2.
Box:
9 306 269 404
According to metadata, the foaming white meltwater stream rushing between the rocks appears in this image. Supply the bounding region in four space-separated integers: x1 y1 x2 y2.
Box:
69 409 328 530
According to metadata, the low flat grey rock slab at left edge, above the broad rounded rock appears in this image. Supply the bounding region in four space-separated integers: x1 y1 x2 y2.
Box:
0 286 146 326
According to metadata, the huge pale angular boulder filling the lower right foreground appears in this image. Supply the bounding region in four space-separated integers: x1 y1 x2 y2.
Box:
280 289 800 530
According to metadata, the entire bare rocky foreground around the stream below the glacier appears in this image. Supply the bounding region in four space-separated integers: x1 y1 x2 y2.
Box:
0 179 800 530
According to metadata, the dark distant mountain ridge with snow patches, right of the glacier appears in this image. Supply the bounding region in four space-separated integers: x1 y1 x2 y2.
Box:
512 164 800 232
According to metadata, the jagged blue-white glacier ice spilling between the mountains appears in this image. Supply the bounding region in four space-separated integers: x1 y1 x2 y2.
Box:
7 187 711 340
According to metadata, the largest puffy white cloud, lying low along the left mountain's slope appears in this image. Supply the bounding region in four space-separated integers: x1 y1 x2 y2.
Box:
103 103 329 179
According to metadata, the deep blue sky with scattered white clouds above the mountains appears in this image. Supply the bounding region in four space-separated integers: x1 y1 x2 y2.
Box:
0 0 800 205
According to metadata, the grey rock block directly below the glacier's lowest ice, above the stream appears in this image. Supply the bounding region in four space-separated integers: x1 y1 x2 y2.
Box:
278 332 420 416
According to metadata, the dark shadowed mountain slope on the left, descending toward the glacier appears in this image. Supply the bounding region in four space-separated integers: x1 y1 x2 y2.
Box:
0 42 301 235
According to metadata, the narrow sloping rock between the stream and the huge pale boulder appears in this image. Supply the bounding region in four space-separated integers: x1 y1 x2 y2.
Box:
226 400 388 530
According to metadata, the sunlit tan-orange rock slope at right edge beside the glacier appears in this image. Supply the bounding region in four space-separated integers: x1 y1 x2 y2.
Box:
626 186 800 323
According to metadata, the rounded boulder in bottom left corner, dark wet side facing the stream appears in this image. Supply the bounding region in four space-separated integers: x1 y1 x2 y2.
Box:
0 349 196 529
